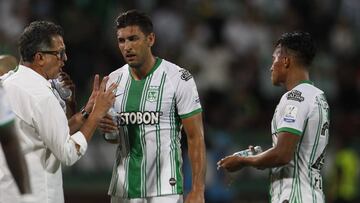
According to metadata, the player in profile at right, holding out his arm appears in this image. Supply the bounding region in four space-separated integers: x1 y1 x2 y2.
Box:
218 32 330 203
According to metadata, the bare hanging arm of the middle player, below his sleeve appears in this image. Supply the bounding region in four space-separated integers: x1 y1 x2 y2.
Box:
182 113 206 203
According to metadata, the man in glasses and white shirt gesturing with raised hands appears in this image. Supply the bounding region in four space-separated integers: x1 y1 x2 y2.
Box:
0 21 115 203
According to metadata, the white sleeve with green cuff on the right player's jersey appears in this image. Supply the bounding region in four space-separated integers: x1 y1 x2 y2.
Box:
277 89 310 136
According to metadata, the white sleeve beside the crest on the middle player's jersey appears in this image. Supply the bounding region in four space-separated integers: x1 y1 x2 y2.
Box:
175 69 202 119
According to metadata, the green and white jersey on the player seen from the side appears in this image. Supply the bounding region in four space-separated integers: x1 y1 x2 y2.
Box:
270 81 329 203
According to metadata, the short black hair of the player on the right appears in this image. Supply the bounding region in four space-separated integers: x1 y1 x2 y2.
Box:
276 31 316 66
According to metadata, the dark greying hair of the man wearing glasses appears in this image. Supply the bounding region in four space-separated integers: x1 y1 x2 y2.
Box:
18 21 64 62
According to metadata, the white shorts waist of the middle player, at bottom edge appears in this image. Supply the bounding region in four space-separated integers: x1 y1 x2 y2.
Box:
111 195 183 203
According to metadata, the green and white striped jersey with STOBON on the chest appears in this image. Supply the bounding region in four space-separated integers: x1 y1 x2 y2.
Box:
108 58 202 198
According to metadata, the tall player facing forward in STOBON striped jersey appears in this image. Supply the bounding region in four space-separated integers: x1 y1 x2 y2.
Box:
100 10 206 203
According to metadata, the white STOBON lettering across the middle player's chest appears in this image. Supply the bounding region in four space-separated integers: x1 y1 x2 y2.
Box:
118 111 160 125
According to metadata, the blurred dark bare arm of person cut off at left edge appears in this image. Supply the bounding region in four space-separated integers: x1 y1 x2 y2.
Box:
0 124 31 194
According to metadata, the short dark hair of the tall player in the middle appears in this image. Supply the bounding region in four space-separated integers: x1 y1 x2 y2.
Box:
116 10 153 35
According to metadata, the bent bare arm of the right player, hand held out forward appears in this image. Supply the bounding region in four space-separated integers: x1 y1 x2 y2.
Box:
218 132 300 172
